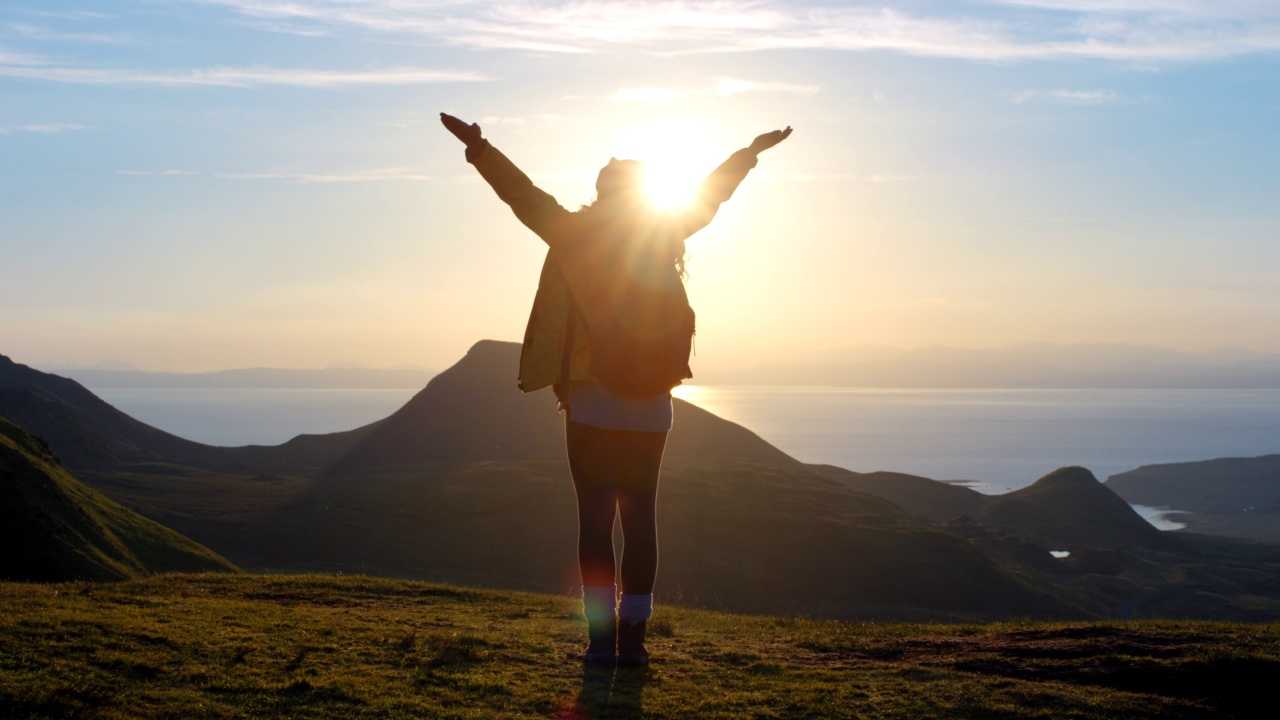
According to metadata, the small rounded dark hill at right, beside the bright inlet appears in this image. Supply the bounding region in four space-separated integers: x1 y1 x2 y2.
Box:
977 468 1162 550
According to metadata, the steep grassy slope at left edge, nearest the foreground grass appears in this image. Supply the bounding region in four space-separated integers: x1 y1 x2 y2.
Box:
0 418 236 580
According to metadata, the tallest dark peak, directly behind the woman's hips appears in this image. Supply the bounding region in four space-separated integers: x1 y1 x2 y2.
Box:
339 340 800 470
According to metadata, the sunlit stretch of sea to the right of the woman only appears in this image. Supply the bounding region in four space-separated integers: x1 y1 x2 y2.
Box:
677 386 1280 492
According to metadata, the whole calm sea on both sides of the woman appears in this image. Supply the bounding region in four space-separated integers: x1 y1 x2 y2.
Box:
95 386 1280 525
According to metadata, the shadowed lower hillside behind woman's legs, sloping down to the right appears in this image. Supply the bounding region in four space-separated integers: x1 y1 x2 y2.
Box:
80 460 1085 620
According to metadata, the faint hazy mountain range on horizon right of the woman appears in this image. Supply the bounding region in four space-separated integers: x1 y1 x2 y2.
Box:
698 343 1280 389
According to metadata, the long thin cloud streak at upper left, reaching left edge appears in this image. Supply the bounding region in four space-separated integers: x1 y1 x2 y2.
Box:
0 64 490 87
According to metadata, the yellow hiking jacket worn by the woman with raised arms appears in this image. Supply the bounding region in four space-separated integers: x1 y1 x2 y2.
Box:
467 142 756 396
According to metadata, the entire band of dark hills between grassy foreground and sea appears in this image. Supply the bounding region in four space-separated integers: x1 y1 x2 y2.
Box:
0 341 1280 620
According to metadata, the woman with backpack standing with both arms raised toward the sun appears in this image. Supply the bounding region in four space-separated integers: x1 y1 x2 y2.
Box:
440 113 791 666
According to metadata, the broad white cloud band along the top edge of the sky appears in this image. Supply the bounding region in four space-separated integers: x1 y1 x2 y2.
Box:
189 0 1280 61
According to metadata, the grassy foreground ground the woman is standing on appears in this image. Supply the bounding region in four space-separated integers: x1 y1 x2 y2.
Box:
0 575 1280 720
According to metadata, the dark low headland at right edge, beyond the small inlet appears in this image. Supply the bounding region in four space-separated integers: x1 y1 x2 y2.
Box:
1106 455 1280 541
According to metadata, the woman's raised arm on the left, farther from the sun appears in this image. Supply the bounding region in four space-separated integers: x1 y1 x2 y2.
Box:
440 113 570 245
